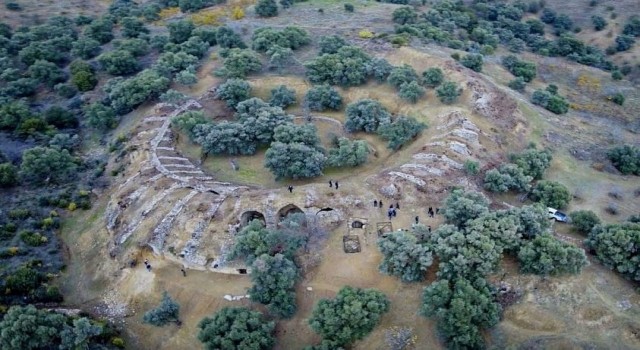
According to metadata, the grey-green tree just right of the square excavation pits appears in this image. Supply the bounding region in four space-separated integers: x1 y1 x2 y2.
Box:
378 232 433 282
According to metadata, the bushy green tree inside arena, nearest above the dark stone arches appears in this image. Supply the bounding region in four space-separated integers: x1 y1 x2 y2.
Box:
265 142 326 179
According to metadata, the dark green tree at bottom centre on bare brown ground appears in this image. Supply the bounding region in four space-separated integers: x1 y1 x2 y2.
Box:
309 286 389 346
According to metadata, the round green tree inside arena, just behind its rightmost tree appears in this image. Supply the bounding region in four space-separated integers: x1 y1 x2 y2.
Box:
344 99 391 133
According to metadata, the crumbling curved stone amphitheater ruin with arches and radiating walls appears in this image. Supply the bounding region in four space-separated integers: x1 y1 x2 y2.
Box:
105 72 522 273
